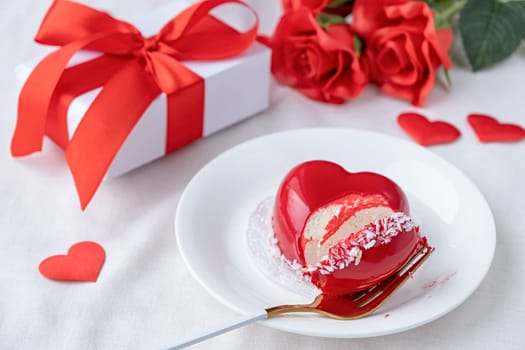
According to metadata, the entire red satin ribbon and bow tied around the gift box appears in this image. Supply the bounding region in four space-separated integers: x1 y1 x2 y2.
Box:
11 0 258 209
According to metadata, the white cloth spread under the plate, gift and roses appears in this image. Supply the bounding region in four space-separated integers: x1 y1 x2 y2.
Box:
0 0 525 350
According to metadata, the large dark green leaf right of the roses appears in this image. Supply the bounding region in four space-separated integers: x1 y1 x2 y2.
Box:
459 0 525 71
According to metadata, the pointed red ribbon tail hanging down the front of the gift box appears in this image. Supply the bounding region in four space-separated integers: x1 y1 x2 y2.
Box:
66 61 161 210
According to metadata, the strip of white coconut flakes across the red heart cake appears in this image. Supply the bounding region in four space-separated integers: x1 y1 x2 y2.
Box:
316 212 418 275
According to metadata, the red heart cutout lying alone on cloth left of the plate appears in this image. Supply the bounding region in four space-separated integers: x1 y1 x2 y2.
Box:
38 242 106 282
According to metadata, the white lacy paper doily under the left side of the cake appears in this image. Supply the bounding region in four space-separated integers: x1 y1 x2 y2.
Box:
246 198 320 298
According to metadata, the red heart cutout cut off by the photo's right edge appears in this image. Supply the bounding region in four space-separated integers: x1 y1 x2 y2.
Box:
467 114 525 142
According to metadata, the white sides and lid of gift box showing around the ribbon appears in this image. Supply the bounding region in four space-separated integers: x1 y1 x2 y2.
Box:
16 0 271 177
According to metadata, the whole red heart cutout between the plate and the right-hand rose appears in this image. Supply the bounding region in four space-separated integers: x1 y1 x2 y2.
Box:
397 113 461 146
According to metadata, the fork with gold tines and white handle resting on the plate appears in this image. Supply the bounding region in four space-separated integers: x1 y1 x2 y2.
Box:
168 246 434 350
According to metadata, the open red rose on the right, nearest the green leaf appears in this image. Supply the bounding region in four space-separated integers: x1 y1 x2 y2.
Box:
352 0 452 106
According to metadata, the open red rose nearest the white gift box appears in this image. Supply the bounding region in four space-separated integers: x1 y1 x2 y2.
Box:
270 8 368 103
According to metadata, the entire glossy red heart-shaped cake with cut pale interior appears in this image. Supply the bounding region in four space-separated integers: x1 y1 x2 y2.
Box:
273 160 427 295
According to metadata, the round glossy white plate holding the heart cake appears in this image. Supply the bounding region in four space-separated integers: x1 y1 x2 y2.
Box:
175 128 496 338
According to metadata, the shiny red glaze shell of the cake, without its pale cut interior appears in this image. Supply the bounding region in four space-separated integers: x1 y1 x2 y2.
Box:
273 160 419 294
